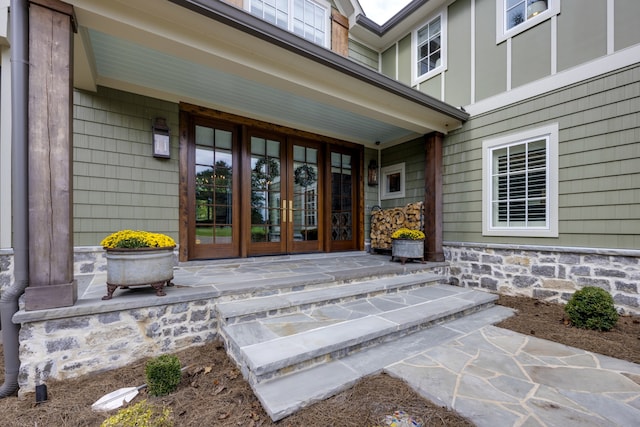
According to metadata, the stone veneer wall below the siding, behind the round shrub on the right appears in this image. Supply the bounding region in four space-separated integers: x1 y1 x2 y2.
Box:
444 242 640 314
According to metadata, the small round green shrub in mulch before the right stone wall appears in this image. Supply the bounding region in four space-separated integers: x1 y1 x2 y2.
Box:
564 286 618 331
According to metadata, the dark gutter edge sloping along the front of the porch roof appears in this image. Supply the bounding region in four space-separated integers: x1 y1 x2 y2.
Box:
169 0 469 122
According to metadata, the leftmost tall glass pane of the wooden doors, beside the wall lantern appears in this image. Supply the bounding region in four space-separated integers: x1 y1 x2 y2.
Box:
194 126 233 245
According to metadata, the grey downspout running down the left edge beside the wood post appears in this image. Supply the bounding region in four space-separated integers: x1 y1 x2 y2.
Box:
0 0 29 398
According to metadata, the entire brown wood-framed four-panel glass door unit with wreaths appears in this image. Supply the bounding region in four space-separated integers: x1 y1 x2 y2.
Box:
180 107 363 261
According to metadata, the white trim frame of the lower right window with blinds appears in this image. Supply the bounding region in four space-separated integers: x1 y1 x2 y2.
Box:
482 123 558 237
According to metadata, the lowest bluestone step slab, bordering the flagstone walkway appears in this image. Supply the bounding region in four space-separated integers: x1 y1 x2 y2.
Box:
252 306 513 421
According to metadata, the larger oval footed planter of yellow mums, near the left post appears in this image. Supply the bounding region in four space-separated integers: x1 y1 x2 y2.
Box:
100 230 176 300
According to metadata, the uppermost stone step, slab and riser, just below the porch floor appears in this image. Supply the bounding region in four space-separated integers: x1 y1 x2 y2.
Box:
216 272 445 325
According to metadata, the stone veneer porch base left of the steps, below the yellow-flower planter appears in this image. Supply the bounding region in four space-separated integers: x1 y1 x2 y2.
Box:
18 299 218 395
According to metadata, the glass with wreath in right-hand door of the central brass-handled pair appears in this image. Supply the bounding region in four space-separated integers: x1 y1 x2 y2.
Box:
293 145 318 240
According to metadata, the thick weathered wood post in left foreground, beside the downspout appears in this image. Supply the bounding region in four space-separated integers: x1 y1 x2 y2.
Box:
25 0 77 310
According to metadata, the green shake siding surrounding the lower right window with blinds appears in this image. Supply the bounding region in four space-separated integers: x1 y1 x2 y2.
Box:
443 65 640 249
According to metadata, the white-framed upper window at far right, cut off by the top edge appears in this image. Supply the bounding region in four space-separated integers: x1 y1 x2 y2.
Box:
496 0 560 43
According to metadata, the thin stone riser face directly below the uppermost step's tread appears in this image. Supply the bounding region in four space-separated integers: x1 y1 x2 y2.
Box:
218 278 443 325
